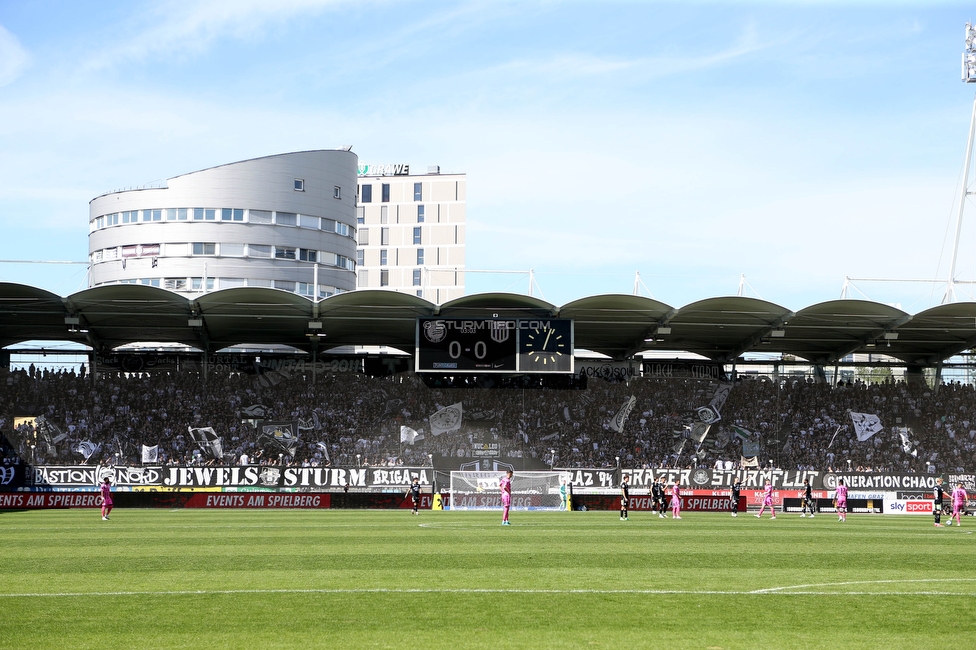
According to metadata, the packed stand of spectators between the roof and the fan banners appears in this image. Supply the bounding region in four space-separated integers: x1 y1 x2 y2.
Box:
0 367 976 473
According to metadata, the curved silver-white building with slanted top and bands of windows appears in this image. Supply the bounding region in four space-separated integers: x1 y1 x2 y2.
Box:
88 150 358 298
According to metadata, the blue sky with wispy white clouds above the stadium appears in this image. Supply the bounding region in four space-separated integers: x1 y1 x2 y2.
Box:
0 0 976 313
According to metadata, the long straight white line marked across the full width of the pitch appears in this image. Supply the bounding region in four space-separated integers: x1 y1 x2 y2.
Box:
0 580 973 599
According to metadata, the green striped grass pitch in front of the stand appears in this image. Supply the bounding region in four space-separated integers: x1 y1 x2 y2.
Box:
0 509 976 650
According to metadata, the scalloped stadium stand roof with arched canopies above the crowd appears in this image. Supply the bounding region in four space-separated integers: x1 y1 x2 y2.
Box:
0 283 976 366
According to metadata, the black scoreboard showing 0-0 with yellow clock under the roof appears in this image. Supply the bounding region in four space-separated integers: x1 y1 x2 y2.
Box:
416 318 573 373
